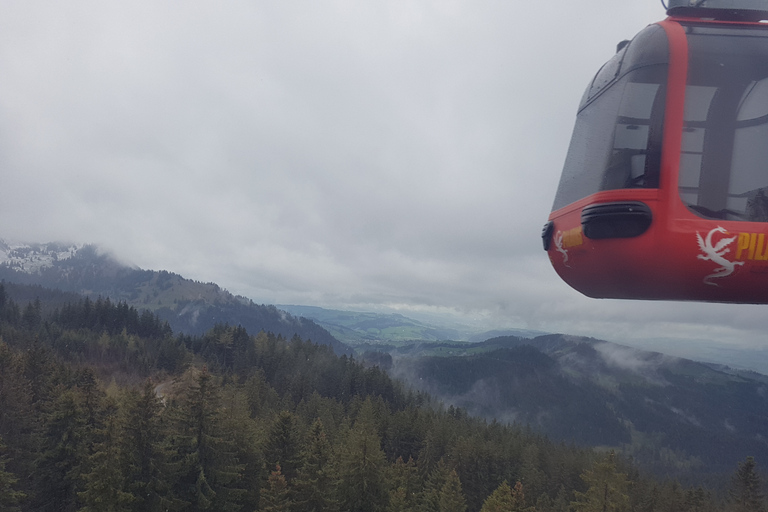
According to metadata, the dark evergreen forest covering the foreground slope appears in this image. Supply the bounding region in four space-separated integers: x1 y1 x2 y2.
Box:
0 283 766 512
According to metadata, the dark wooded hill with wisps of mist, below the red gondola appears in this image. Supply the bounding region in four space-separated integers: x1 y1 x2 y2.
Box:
391 335 768 477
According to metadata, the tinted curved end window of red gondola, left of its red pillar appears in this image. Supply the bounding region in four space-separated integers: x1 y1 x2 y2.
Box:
552 26 669 210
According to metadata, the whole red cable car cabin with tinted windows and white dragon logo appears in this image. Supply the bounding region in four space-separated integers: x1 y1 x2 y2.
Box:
542 0 768 303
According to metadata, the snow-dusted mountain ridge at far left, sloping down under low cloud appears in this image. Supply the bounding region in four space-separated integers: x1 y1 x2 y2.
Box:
0 241 352 355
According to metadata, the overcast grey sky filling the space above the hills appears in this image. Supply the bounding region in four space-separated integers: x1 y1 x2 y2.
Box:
0 0 768 352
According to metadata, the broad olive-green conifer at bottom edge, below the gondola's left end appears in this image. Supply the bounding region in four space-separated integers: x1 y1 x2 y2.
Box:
571 451 629 512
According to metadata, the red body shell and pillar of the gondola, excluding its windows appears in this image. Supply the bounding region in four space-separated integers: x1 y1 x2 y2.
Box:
548 18 768 303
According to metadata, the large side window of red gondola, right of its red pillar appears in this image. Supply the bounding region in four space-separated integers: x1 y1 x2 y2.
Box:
679 27 768 222
